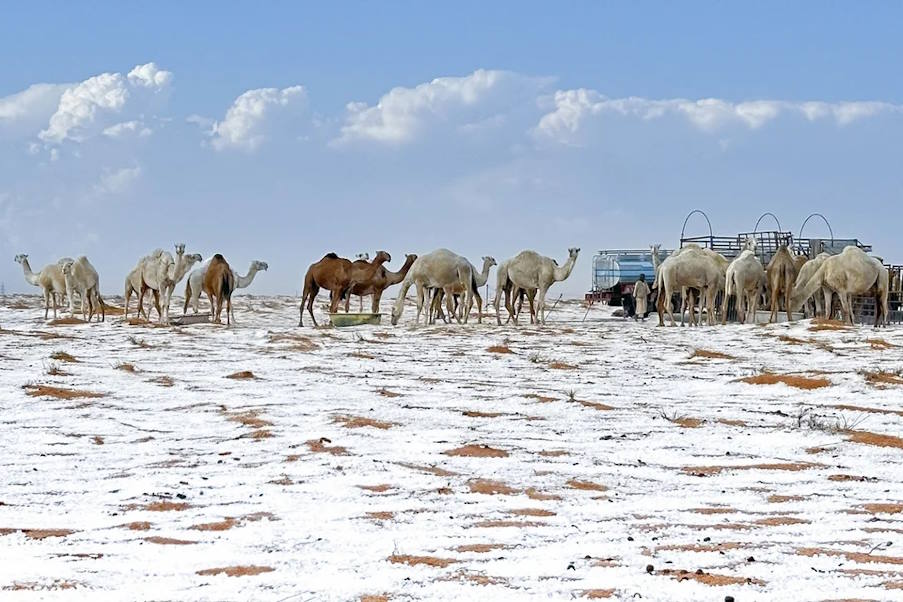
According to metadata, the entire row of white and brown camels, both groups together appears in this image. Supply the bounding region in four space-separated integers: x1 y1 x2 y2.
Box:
15 238 888 327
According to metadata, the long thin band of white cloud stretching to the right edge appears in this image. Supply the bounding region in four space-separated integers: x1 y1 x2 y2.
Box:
534 88 903 143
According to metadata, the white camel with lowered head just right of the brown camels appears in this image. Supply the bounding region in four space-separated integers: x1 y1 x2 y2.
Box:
392 249 476 326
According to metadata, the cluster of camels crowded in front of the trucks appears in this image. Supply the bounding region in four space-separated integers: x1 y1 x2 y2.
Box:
652 238 889 327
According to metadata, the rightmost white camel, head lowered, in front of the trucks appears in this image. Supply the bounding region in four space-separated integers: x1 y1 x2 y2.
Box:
788 246 889 328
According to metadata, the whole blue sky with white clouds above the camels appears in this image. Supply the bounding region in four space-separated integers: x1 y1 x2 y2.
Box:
0 2 903 294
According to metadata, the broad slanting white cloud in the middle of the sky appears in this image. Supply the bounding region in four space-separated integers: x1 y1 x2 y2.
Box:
334 69 546 145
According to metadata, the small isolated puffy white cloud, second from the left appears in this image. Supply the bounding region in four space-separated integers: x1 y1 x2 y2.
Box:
210 86 307 151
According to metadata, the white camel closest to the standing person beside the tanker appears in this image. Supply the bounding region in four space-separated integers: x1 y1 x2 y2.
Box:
655 244 726 326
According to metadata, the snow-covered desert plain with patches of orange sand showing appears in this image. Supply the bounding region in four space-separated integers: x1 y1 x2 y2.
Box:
0 296 903 601
